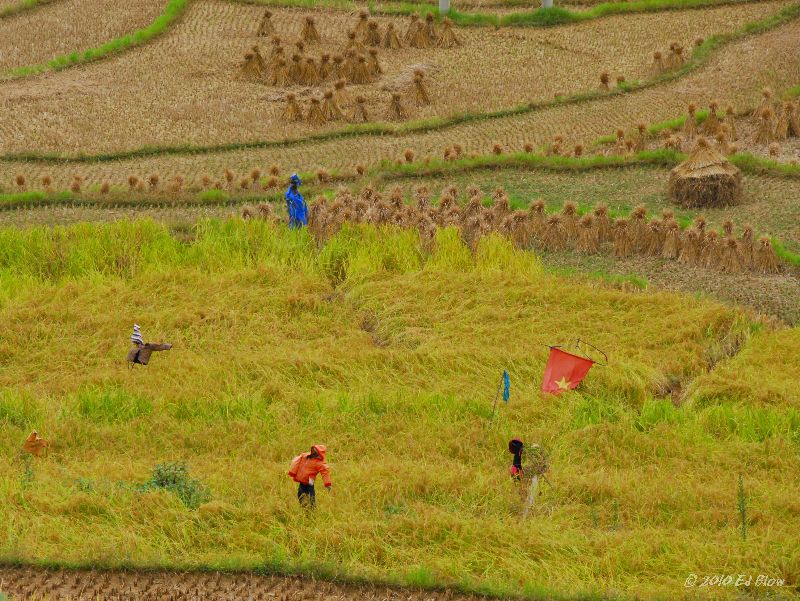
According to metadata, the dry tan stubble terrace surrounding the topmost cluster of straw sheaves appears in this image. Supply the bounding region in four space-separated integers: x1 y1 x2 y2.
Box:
0 0 796 154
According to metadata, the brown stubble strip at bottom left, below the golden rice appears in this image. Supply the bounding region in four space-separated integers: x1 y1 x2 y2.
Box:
0 567 479 601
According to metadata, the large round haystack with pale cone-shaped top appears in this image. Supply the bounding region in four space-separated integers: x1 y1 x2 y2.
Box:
669 137 742 207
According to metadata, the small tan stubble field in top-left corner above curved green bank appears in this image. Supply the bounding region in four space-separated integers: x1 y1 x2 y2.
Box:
0 0 166 71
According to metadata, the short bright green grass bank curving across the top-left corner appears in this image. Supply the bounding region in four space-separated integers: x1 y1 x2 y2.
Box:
0 0 189 82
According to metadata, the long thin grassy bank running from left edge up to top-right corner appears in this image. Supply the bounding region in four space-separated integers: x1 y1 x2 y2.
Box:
0 0 800 164
